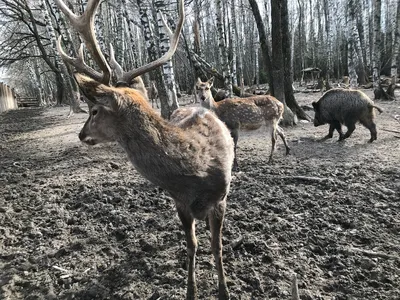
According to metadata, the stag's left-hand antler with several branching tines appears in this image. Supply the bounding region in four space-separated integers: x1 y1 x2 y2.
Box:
55 0 111 85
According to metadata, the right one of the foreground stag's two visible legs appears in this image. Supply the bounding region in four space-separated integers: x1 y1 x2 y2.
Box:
208 196 230 300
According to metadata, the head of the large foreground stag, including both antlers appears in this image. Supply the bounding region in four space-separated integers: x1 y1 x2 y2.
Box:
55 0 185 145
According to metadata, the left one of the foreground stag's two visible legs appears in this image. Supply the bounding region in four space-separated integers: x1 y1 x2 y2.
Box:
177 205 197 300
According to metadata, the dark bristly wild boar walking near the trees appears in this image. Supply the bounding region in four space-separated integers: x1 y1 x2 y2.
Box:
312 89 382 142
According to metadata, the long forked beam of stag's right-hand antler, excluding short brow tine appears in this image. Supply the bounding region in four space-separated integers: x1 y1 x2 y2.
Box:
123 0 185 83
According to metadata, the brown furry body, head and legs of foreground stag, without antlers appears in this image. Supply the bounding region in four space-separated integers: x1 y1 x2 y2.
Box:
77 76 234 299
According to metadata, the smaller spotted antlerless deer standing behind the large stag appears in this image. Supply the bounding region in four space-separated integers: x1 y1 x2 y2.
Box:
196 77 290 170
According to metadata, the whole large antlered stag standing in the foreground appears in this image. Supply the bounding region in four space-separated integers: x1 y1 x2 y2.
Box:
55 0 234 300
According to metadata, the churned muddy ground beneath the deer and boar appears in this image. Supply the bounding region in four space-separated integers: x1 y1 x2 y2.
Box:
0 91 400 300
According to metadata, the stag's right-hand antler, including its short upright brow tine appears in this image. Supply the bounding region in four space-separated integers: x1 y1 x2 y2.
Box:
110 0 185 84
